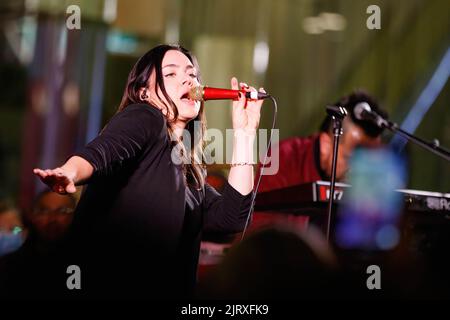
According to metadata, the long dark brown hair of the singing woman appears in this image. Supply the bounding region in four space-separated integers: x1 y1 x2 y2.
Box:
117 44 206 189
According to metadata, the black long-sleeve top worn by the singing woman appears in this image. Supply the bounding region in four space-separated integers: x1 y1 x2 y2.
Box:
69 104 250 298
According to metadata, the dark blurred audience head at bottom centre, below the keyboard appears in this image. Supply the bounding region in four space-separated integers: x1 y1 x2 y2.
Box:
198 227 337 299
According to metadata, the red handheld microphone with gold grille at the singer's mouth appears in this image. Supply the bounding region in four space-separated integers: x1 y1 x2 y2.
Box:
189 86 270 101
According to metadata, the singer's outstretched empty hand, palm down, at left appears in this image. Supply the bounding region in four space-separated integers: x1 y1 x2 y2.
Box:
33 168 77 194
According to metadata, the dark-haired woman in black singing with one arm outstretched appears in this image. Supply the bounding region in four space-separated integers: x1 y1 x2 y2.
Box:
34 45 263 298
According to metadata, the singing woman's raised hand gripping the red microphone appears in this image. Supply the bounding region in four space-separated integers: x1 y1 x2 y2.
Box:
231 77 265 132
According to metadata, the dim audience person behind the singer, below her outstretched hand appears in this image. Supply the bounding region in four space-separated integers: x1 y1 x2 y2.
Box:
0 190 76 299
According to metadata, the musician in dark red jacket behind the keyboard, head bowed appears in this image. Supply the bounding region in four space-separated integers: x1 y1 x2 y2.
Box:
257 90 387 192
